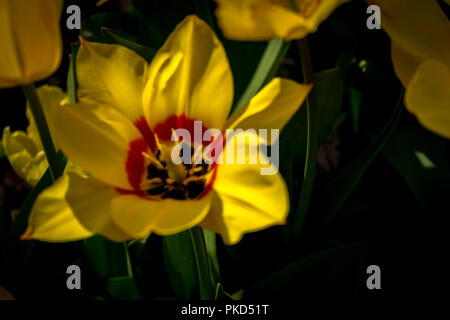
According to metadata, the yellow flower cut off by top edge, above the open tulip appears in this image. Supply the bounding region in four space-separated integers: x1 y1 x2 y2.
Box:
216 0 350 41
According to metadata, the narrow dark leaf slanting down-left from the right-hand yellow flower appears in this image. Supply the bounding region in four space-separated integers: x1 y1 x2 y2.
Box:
314 90 403 230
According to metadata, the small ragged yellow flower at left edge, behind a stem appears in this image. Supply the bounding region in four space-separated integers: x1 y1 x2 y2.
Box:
2 85 66 186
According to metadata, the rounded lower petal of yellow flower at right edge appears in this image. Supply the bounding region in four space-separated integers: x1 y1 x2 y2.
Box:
405 60 450 139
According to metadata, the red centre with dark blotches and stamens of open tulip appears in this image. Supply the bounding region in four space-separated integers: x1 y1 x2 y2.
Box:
124 115 217 200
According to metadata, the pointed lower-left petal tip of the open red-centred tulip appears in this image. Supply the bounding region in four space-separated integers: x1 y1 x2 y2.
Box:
22 175 93 242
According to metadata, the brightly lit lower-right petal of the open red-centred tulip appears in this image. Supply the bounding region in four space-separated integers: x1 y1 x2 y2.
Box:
201 131 289 245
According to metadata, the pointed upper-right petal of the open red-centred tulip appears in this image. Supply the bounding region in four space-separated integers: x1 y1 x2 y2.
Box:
226 78 312 142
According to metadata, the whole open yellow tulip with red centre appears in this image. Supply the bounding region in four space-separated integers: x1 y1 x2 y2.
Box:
25 16 311 244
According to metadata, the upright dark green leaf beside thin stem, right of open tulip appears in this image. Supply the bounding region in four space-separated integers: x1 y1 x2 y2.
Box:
288 69 344 237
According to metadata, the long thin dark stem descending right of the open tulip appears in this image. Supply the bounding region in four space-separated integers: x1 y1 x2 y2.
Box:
293 38 318 238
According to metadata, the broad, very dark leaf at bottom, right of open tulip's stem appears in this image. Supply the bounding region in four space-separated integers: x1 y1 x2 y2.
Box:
243 242 365 300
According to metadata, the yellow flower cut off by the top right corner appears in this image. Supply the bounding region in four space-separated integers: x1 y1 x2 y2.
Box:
368 0 450 139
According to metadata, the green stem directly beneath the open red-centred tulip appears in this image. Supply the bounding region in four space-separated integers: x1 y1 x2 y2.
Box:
189 227 215 300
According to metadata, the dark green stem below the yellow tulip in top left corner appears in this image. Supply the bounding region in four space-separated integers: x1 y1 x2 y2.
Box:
22 83 62 181
